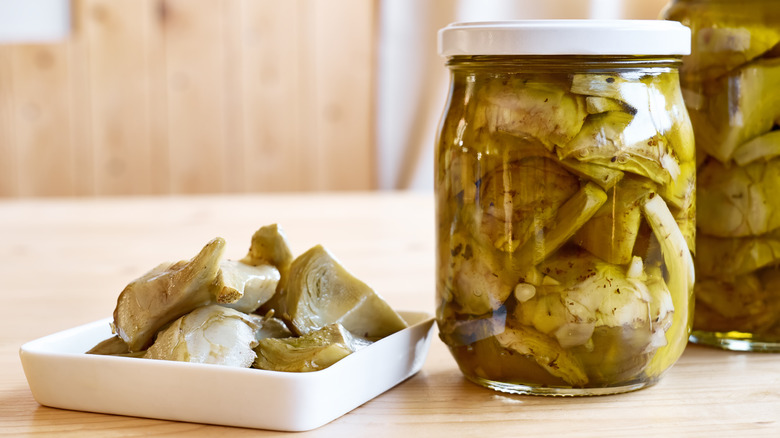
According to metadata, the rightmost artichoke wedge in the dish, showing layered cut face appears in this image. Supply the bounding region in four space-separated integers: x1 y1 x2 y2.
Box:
278 245 406 339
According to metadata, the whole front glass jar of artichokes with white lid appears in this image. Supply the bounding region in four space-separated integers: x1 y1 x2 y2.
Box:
435 20 696 395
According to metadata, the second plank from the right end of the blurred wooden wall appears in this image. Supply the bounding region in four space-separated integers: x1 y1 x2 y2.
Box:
243 0 306 190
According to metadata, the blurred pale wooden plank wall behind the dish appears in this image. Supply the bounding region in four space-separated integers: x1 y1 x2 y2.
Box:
0 0 378 197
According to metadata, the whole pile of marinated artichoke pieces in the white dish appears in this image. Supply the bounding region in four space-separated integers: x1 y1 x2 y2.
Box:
92 225 406 371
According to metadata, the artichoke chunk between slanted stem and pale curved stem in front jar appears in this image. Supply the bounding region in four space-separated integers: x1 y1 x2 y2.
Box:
574 177 655 265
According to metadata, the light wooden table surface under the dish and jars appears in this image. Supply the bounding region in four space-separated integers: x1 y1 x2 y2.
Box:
0 193 780 437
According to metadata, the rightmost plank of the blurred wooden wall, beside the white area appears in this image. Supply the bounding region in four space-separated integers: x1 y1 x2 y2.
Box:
303 0 377 189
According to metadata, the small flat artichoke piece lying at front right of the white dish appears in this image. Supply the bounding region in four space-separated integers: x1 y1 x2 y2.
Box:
253 324 370 372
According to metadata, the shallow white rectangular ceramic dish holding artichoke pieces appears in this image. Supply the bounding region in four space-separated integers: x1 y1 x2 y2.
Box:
19 312 433 431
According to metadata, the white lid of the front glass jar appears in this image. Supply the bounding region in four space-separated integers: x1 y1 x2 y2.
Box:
439 20 691 57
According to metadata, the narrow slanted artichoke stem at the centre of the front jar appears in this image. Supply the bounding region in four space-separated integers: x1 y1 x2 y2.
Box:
513 182 607 267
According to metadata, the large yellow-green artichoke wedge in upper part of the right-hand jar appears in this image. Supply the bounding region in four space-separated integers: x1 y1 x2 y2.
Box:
689 58 780 163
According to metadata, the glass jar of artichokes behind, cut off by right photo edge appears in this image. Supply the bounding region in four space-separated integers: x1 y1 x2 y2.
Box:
663 0 780 352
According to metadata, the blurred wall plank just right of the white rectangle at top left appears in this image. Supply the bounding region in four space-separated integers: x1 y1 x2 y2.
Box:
81 0 160 195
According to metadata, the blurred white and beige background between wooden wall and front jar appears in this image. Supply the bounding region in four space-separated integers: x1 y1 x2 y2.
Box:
377 0 667 190
